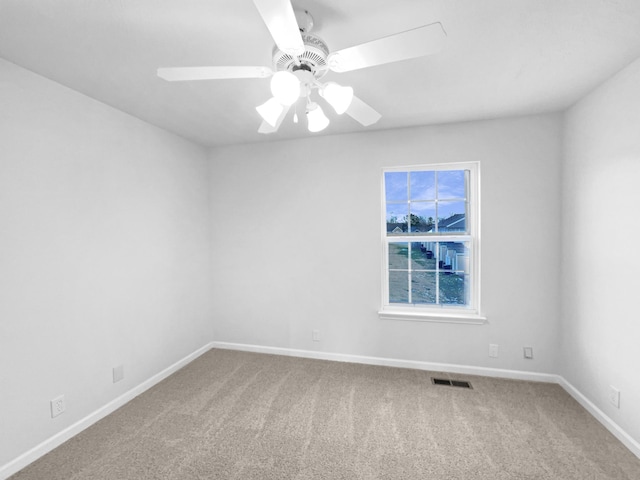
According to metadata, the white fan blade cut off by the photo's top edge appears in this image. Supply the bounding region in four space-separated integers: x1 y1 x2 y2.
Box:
253 0 304 56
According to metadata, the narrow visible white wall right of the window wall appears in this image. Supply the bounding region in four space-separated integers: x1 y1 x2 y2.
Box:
561 59 640 441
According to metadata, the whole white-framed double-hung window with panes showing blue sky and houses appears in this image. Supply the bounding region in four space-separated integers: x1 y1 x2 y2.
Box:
380 163 484 323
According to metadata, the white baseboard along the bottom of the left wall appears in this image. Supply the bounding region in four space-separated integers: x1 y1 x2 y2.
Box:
0 344 212 479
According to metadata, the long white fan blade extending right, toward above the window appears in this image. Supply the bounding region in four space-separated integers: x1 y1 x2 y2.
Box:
328 23 447 72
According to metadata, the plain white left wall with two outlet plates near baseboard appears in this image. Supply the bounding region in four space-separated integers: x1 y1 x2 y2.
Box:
0 60 211 468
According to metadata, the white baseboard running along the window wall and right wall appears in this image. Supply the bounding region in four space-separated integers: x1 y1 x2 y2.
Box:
211 342 640 458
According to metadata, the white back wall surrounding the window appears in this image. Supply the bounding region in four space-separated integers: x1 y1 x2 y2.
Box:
211 115 562 373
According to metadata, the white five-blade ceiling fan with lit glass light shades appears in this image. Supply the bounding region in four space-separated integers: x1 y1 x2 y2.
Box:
158 0 446 134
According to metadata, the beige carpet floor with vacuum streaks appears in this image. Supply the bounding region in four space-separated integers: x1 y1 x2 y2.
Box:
11 350 640 480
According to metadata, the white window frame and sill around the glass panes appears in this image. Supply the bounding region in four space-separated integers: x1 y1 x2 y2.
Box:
378 162 487 324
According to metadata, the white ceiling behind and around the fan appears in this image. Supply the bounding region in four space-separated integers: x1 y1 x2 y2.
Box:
0 0 640 146
